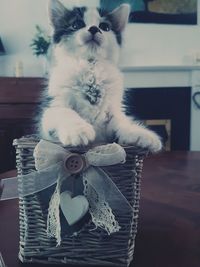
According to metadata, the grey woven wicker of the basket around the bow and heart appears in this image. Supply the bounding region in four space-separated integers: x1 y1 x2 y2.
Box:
14 137 146 267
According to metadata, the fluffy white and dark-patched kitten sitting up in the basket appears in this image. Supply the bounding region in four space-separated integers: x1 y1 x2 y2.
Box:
40 0 162 152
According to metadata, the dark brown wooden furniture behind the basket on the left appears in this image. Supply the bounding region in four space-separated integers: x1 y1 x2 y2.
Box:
0 77 44 173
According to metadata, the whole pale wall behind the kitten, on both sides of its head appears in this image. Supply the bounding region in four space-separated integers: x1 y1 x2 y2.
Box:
0 0 200 76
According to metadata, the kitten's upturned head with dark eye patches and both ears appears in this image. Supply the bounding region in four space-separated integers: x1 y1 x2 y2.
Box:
50 0 129 62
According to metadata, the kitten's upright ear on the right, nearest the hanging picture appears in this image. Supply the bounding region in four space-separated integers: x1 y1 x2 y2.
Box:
108 4 131 32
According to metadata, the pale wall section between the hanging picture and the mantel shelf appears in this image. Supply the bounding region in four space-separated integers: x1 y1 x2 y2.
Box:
123 18 200 66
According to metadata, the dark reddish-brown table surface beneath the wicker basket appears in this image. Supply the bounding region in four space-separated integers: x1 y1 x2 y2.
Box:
0 152 200 267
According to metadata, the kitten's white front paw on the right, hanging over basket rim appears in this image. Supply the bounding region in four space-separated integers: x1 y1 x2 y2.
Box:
119 127 162 153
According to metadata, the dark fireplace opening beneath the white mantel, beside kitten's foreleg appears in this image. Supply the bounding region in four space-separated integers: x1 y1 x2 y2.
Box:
124 87 191 150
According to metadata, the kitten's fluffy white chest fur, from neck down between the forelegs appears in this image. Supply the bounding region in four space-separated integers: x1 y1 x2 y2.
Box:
50 60 123 141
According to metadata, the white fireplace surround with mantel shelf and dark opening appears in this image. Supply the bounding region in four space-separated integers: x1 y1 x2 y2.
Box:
121 65 200 151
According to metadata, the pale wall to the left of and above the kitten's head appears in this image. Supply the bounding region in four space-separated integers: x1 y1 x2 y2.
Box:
0 0 99 76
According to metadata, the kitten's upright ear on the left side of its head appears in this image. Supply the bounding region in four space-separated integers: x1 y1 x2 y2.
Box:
48 0 68 27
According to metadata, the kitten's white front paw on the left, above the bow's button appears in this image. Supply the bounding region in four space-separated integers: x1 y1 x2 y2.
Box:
57 122 95 146
